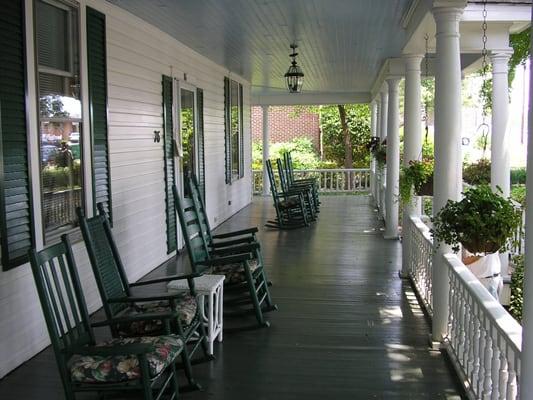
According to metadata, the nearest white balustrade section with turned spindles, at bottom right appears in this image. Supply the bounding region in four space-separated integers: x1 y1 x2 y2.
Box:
444 254 522 400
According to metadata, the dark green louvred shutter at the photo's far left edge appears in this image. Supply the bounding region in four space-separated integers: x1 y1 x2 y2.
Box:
0 0 34 270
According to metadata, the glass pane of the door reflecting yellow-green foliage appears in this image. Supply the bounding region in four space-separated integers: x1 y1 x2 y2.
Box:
180 89 197 195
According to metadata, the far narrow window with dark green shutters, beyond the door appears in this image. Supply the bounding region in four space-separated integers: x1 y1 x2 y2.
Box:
225 78 244 183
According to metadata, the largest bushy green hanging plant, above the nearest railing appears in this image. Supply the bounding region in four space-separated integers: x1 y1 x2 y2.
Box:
431 185 521 254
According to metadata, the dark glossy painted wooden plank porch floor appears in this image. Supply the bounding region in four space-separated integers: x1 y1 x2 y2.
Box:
0 196 462 400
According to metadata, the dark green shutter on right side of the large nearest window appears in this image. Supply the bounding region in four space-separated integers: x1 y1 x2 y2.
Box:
87 7 113 221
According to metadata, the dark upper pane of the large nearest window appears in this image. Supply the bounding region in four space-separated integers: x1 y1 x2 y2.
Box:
36 1 70 71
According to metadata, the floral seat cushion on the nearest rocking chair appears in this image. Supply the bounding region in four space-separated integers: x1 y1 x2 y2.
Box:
69 335 183 383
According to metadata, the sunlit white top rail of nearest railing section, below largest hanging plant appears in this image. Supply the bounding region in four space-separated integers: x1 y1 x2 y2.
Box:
443 254 522 353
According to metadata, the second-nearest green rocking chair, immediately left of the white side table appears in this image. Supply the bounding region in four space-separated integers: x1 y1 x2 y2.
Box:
76 203 208 390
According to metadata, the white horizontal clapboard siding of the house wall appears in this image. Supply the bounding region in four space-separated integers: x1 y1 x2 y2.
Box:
0 0 251 377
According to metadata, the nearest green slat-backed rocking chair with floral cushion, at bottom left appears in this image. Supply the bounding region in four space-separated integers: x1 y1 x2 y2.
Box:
30 235 184 400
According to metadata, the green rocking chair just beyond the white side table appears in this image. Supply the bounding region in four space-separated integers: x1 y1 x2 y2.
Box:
172 185 277 327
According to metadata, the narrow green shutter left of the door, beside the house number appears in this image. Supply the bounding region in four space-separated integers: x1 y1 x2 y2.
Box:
163 75 178 253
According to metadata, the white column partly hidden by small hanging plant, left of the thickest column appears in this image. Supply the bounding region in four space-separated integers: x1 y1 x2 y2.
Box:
400 54 423 278
